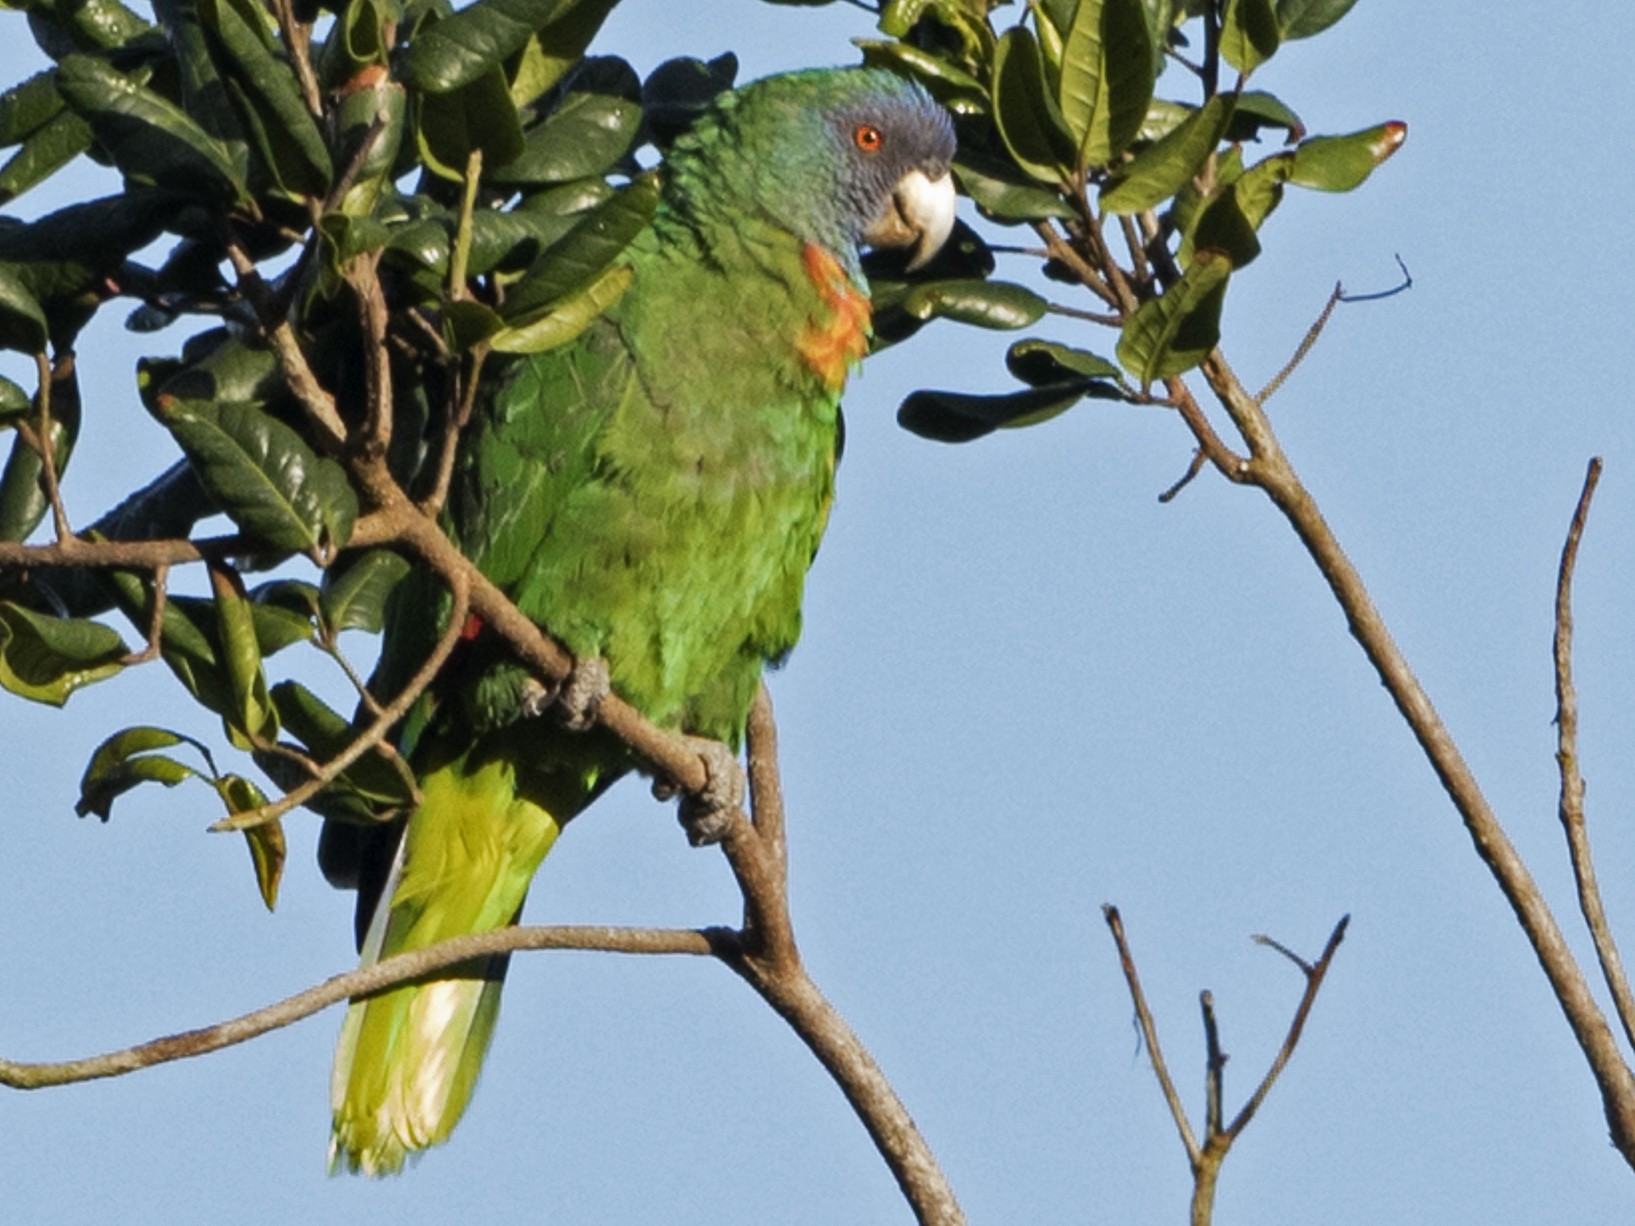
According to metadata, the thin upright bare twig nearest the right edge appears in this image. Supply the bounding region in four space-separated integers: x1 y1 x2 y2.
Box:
1555 456 1635 1046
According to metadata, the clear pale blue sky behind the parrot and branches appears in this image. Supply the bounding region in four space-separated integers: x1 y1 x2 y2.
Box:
0 0 1635 1226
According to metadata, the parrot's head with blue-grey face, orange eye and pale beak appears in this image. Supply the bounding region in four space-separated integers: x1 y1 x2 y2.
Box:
669 69 955 280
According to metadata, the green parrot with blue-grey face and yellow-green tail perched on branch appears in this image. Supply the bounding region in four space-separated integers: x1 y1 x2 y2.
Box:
320 69 955 1175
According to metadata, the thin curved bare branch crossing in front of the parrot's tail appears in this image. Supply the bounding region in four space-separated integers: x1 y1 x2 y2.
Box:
0 927 716 1090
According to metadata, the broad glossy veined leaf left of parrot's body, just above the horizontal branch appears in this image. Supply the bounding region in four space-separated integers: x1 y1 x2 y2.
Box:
159 396 358 553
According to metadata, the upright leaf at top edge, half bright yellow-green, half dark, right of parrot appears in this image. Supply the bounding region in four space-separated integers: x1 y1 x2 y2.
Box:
1059 0 1158 167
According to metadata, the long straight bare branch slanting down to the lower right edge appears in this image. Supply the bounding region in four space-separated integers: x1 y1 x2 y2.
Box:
1203 350 1635 1166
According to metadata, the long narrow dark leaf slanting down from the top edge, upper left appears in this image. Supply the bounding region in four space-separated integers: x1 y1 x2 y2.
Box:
198 0 334 196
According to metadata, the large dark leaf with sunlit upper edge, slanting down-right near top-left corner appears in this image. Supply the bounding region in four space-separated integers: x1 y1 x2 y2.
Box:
57 56 245 199
